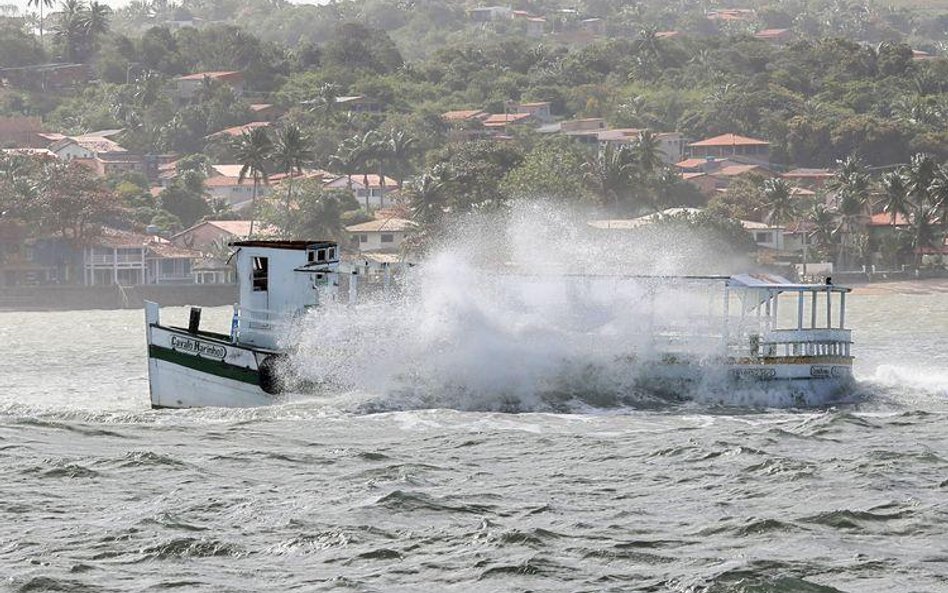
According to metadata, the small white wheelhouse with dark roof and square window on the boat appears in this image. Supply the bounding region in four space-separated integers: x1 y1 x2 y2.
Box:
230 241 339 348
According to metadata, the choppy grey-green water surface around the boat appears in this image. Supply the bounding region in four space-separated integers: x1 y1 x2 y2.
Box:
0 294 948 593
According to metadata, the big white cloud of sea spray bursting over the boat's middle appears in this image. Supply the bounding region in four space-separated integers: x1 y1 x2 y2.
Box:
287 203 776 411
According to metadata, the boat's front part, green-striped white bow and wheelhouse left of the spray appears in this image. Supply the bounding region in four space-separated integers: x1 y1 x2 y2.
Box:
145 240 344 409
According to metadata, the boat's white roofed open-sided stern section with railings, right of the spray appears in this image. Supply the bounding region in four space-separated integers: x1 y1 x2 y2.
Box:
624 274 854 405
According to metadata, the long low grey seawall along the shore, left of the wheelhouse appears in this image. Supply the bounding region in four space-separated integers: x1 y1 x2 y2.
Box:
0 284 237 311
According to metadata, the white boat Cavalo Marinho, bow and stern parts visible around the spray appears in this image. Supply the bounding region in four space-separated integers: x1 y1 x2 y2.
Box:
145 240 854 408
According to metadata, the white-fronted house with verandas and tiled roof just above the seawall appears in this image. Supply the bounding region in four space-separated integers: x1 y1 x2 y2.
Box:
81 228 202 286
